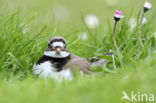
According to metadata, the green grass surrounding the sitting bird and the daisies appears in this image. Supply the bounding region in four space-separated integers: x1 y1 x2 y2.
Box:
0 0 156 103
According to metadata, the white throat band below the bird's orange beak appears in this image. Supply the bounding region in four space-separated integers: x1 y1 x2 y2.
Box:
44 51 69 58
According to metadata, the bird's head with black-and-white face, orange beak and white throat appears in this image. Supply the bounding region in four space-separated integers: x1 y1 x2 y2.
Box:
44 36 70 58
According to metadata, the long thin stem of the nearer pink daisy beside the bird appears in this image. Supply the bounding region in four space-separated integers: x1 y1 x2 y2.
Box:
113 21 122 67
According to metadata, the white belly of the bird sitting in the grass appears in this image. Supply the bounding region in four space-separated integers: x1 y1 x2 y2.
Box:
33 61 73 81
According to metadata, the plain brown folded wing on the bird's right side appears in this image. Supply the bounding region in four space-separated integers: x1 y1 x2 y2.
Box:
64 54 92 74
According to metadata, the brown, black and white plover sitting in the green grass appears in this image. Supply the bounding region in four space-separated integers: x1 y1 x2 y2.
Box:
33 36 94 81
